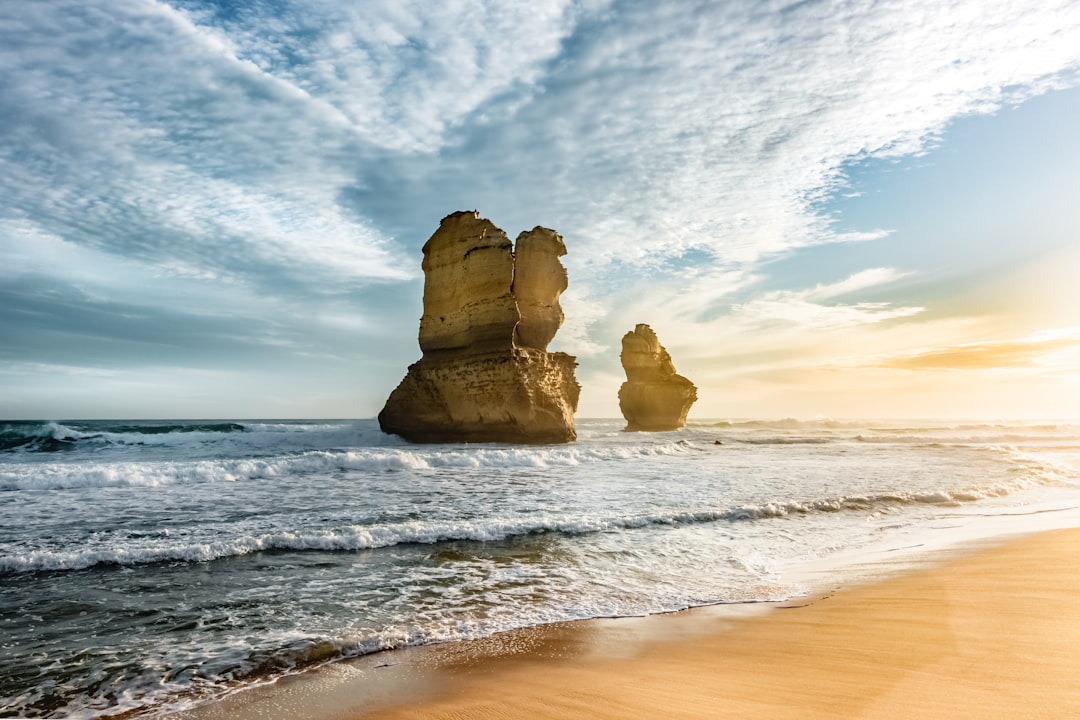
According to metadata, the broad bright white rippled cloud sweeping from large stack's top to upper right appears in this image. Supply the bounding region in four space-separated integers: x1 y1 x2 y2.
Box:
401 2 1080 272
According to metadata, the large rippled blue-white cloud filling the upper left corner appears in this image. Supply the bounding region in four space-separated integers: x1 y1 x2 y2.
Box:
0 0 415 283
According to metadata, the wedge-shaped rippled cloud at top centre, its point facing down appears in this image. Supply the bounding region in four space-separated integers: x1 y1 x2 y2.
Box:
177 0 606 152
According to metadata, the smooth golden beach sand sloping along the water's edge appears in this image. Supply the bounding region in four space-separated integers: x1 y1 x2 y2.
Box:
181 529 1080 720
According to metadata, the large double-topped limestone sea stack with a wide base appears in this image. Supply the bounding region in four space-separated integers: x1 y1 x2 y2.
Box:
379 212 581 443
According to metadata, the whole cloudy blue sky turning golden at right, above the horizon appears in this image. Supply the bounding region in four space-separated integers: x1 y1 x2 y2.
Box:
0 0 1080 420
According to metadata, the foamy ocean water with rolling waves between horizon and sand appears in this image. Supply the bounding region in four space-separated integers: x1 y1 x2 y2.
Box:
0 420 1080 718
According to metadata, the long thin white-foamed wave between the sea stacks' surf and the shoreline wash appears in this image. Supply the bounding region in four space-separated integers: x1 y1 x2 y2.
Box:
0 465 1059 574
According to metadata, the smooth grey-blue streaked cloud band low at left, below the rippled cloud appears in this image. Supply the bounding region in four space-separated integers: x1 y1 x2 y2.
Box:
0 228 415 371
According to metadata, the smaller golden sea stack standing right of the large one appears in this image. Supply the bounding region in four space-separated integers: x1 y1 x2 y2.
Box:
619 325 698 431
